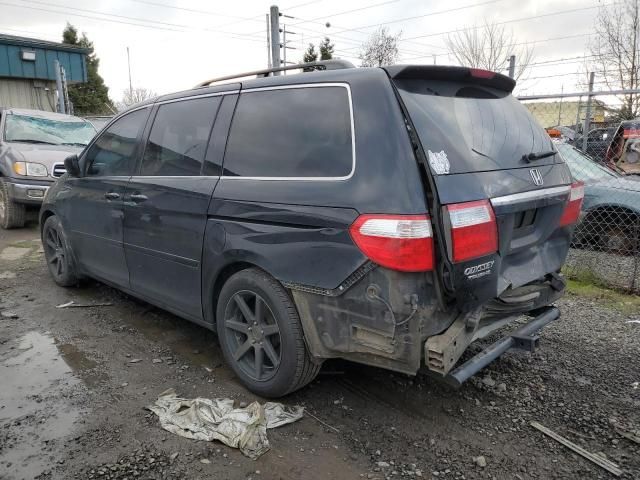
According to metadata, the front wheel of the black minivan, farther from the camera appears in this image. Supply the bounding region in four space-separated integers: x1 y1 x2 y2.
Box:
42 215 80 287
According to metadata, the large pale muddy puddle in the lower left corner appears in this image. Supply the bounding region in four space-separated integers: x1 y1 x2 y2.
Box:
0 331 95 478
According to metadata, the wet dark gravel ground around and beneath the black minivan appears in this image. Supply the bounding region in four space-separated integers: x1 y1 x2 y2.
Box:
0 227 640 480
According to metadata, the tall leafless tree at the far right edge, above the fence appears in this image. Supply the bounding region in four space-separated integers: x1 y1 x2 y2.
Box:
587 0 640 120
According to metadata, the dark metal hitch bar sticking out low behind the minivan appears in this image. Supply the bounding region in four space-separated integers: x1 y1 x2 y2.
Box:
445 307 560 387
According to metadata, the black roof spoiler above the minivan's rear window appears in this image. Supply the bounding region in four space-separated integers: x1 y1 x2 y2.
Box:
384 65 516 92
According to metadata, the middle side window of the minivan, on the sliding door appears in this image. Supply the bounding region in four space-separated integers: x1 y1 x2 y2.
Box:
140 97 220 176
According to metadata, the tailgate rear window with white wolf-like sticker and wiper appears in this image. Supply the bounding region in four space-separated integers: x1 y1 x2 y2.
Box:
395 79 561 174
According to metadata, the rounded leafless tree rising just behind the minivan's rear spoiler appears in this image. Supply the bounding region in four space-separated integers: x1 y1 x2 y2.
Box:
445 21 533 79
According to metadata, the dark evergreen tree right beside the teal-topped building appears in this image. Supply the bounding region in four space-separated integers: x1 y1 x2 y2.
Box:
62 23 114 115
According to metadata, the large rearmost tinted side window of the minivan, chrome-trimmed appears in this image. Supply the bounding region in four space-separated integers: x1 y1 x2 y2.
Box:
224 87 353 177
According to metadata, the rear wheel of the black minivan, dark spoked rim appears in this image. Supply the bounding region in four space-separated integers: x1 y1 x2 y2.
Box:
216 268 321 398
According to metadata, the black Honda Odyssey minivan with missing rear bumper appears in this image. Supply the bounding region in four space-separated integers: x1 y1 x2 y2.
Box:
40 61 583 397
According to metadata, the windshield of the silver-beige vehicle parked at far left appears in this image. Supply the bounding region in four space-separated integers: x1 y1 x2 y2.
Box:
4 114 96 146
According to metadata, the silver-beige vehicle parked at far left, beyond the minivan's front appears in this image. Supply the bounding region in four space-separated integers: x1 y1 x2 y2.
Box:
0 108 96 229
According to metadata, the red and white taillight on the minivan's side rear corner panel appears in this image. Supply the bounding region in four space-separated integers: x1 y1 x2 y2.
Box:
349 215 433 272
